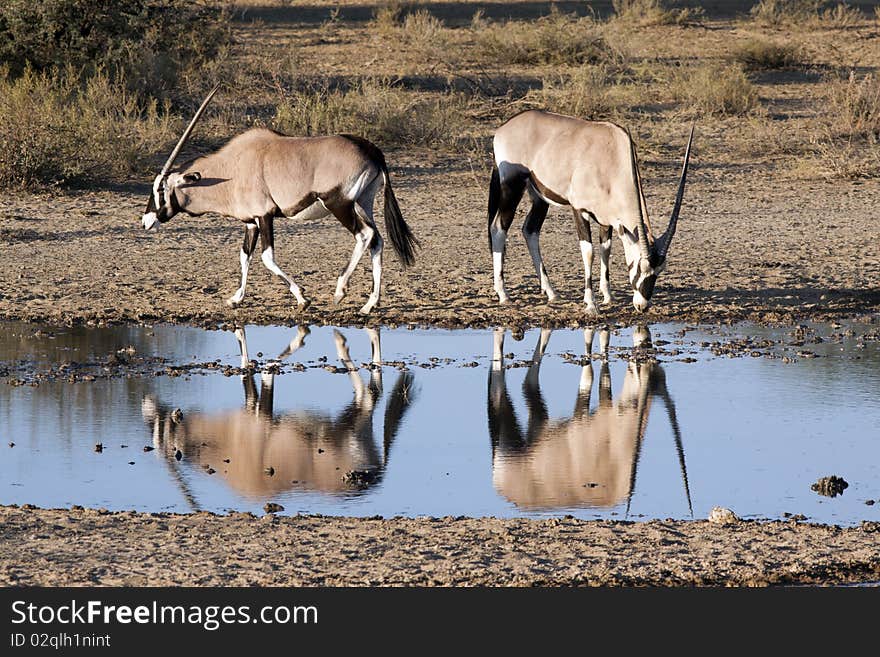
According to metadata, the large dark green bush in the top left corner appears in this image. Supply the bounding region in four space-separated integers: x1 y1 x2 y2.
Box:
0 0 230 93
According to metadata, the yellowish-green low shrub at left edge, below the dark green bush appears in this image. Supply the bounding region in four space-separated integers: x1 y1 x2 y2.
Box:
0 68 177 187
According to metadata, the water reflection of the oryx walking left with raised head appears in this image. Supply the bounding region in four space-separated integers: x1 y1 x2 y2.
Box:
142 327 414 506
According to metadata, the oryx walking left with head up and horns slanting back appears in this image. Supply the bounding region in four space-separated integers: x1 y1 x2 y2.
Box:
142 87 418 314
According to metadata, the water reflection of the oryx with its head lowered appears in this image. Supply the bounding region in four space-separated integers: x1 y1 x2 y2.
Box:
487 327 693 515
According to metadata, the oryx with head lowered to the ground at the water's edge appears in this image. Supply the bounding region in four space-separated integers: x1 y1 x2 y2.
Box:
489 110 694 313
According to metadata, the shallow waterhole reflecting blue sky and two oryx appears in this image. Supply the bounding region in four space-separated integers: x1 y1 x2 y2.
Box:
0 318 880 525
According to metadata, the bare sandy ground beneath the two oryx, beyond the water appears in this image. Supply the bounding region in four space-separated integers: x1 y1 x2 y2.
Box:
0 173 880 334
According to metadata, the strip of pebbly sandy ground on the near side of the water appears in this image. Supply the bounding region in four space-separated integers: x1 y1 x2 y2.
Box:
0 507 880 587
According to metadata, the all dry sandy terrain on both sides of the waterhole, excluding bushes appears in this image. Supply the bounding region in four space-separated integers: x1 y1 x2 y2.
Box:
0 0 880 586
